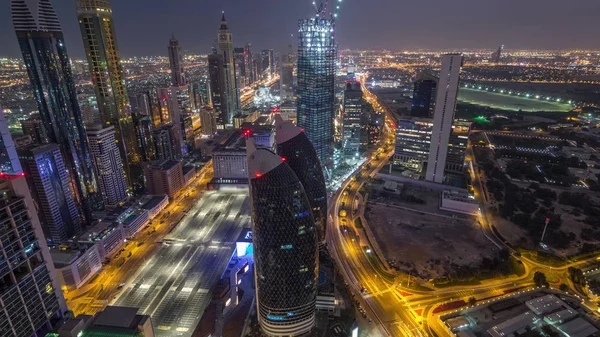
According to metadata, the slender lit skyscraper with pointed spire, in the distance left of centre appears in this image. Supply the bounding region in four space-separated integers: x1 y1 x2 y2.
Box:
217 13 240 125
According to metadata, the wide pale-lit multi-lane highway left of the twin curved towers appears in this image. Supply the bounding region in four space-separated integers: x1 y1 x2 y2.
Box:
112 191 251 337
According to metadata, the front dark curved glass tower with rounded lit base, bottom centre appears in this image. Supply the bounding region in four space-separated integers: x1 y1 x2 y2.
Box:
247 140 318 336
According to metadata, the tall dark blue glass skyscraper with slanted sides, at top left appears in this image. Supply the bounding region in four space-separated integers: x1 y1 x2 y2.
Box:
11 0 102 220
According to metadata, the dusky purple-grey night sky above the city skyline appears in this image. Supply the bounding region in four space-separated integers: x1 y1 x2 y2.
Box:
0 0 600 57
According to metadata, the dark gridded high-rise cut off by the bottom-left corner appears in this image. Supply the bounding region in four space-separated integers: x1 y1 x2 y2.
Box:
0 172 67 336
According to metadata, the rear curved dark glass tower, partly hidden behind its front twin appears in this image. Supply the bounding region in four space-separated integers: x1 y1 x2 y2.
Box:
275 115 327 241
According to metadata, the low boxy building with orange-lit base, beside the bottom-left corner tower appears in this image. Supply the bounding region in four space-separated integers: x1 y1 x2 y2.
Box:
50 244 102 290
